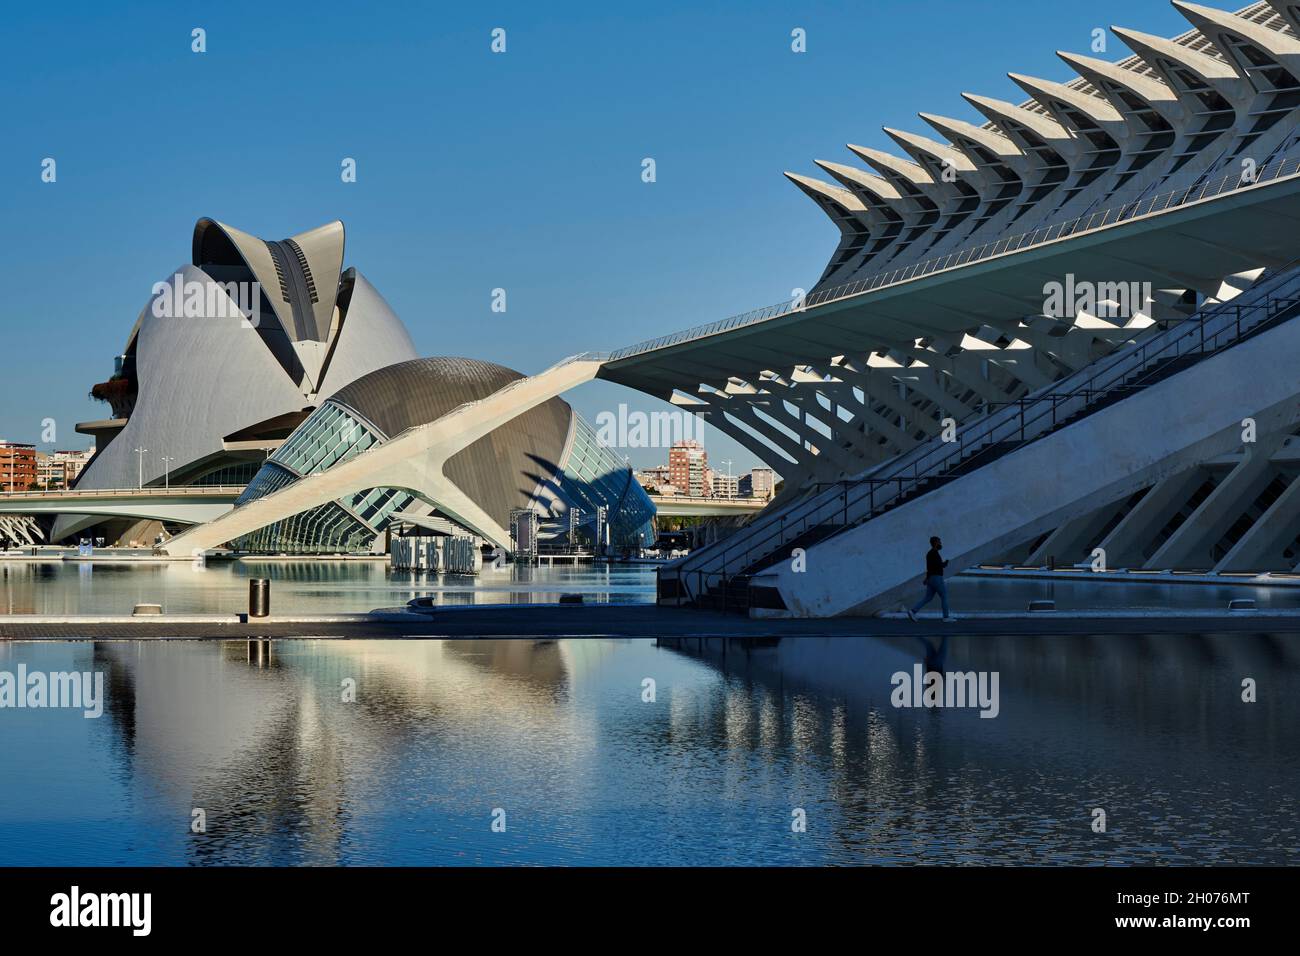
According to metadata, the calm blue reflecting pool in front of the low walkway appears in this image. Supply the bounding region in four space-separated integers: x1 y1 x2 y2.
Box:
0 635 1300 865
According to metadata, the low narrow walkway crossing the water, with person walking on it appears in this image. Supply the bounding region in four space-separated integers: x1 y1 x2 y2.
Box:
0 605 1300 640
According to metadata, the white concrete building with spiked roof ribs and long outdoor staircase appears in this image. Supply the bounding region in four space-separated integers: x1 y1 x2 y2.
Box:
626 0 1300 615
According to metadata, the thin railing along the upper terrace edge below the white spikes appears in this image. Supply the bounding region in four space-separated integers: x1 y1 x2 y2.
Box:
608 156 1300 362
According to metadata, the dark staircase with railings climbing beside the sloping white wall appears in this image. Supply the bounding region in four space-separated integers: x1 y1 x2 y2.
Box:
659 259 1300 613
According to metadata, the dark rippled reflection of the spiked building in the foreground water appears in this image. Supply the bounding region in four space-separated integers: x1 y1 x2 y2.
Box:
660 633 1300 864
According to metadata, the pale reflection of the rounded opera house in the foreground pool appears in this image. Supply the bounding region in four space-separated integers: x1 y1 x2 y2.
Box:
95 640 624 864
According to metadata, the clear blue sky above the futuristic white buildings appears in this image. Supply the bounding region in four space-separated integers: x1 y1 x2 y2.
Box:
0 0 1187 471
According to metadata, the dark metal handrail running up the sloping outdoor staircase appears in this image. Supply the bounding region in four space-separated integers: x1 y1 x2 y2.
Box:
679 259 1300 598
